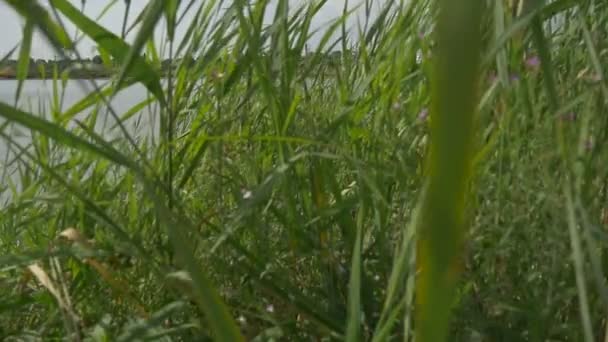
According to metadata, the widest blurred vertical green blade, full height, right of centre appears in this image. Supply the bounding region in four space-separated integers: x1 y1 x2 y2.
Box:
416 0 482 342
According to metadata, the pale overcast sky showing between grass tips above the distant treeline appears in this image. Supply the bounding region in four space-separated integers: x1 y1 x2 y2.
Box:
0 0 385 59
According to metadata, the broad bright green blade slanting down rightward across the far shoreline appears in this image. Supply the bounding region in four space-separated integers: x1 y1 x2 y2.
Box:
50 0 165 104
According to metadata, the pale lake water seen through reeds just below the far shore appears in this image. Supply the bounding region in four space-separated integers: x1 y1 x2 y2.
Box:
0 80 157 154
